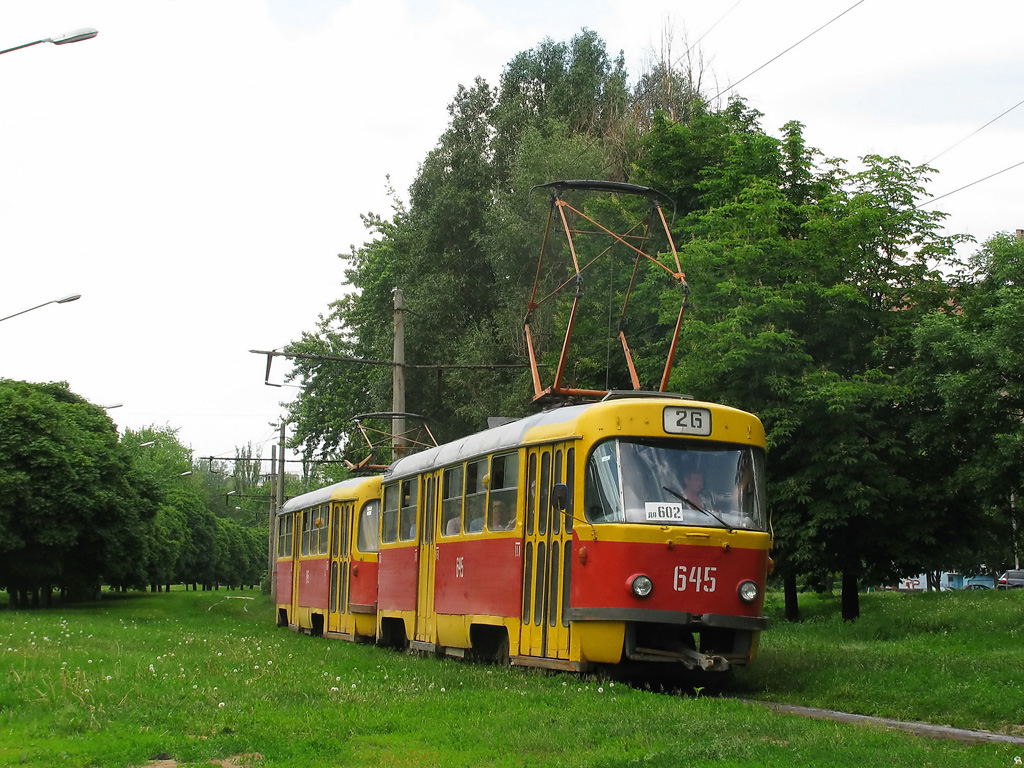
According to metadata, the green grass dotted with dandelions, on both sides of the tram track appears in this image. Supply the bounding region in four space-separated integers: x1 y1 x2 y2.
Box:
0 591 1024 768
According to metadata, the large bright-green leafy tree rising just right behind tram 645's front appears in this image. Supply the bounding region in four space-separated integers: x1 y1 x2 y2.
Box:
644 112 955 618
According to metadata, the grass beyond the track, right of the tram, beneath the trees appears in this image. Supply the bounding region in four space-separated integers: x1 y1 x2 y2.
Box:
737 590 1024 736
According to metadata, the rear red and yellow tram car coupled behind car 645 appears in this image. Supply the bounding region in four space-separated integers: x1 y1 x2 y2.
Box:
275 475 381 642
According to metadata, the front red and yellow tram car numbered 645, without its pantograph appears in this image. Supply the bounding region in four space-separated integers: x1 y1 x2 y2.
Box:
380 391 771 672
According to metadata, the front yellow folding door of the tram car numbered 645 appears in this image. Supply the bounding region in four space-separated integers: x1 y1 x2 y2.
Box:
519 444 572 658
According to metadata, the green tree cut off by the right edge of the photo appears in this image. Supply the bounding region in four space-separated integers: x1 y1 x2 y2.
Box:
914 233 1024 568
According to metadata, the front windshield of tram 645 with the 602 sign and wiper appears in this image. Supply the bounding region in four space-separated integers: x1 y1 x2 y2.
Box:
584 440 765 530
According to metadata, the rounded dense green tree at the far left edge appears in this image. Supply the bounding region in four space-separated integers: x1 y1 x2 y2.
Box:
0 380 157 604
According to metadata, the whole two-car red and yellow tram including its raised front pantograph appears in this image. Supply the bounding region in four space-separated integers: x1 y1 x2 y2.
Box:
278 180 772 673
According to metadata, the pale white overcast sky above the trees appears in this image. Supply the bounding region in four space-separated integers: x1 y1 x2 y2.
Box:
0 0 1024 457
